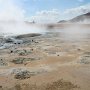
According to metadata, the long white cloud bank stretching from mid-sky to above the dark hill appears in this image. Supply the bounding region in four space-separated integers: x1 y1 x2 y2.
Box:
27 4 90 23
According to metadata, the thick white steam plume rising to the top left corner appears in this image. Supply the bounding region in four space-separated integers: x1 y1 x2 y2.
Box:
0 0 44 34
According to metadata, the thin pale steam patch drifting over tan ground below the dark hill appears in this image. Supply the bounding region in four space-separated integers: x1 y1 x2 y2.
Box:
57 24 90 42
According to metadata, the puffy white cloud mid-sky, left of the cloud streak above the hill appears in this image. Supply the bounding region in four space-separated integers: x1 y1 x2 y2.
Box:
28 9 60 23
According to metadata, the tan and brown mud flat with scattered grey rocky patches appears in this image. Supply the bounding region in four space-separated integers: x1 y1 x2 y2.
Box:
0 26 90 90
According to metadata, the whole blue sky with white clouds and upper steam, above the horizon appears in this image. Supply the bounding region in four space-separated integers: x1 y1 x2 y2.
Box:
0 0 90 23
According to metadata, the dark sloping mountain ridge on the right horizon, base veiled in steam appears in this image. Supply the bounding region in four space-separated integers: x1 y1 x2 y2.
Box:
58 12 90 23
